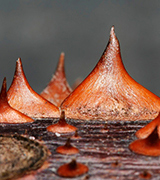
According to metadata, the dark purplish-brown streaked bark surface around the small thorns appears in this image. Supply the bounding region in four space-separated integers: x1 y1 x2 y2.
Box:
0 120 160 180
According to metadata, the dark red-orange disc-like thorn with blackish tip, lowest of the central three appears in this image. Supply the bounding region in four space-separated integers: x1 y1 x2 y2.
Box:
57 159 88 178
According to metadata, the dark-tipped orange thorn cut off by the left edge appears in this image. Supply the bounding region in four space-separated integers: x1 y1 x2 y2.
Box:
0 78 33 123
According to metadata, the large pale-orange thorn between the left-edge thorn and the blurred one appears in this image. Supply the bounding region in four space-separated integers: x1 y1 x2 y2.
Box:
7 58 59 118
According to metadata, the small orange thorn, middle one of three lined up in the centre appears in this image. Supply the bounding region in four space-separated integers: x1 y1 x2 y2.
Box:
56 138 79 154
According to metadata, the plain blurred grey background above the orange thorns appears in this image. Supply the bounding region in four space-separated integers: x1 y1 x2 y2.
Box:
0 0 160 96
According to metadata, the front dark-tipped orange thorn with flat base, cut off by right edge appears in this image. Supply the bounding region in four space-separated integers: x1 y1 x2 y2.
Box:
129 127 160 156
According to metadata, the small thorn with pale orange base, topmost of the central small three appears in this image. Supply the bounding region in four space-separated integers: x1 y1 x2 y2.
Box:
47 111 77 133
